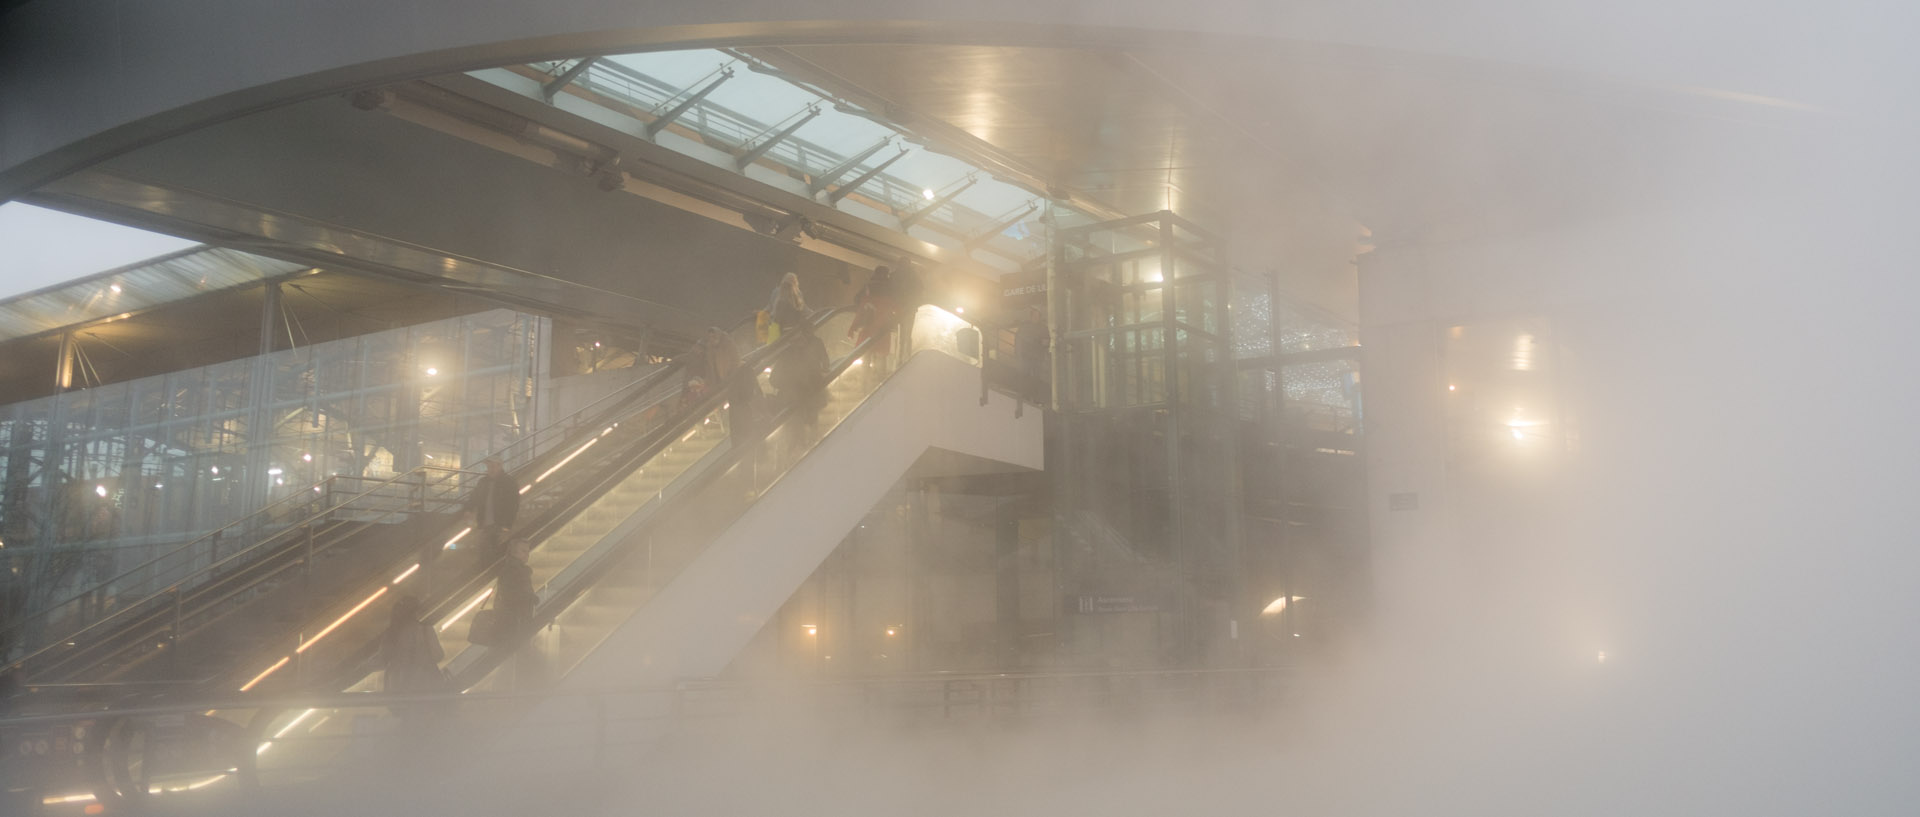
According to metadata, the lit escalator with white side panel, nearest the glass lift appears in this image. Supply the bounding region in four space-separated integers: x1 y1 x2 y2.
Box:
18 307 1041 811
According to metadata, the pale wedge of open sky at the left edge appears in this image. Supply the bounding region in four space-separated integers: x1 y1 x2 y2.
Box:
0 201 194 297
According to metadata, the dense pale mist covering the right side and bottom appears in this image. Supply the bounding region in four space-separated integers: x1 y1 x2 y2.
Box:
11 4 1920 817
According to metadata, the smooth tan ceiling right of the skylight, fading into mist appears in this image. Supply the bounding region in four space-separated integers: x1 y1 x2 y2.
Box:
745 42 1809 313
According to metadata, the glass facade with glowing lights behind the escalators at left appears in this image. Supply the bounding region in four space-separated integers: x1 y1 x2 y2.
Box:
0 309 545 583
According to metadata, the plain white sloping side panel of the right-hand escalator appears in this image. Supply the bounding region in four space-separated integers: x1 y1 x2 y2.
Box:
563 353 1043 690
